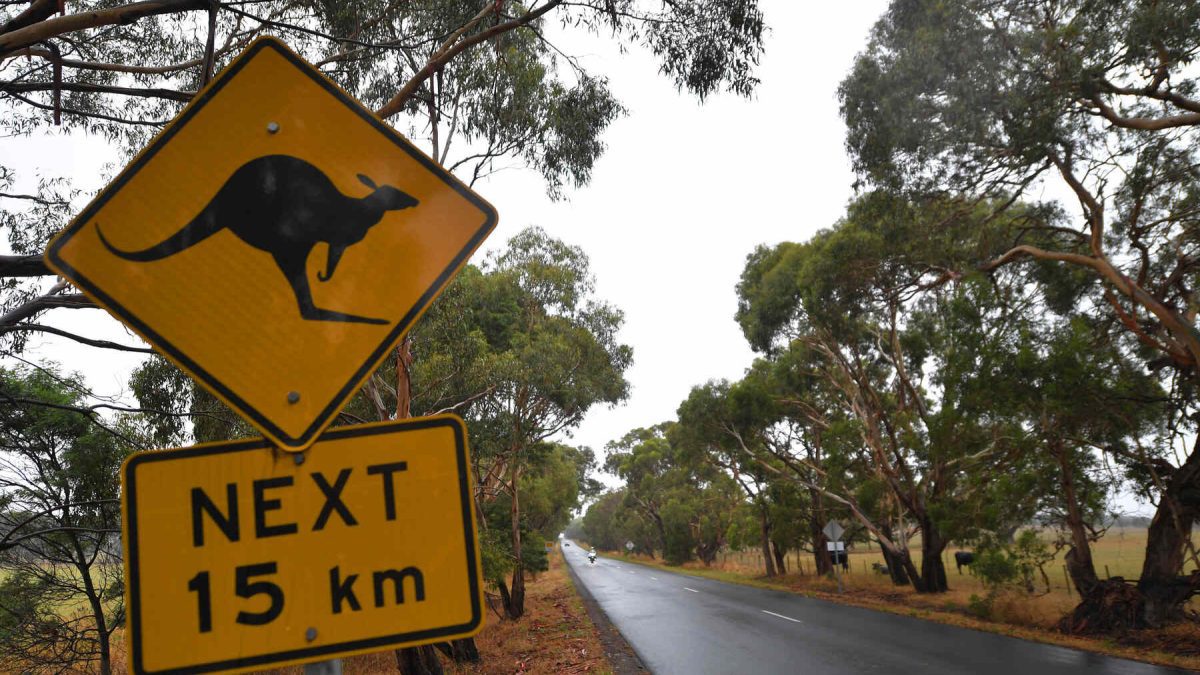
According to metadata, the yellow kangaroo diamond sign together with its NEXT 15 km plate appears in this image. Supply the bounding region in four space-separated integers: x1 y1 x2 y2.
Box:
46 37 497 675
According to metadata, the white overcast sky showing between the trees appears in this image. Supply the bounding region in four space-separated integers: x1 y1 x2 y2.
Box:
9 0 1145 510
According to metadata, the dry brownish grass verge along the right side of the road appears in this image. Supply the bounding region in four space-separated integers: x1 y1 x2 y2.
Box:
605 554 1200 670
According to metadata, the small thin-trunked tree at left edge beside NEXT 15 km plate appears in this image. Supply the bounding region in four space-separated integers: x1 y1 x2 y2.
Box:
0 368 130 674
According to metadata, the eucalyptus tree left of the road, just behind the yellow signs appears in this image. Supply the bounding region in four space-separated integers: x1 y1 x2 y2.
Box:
398 228 632 619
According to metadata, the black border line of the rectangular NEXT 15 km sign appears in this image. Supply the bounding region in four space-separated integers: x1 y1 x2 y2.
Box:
121 414 484 675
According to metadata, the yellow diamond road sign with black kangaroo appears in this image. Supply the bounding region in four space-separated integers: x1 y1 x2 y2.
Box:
46 38 497 450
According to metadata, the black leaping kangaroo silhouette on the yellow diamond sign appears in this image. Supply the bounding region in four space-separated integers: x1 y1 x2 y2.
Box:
96 155 419 324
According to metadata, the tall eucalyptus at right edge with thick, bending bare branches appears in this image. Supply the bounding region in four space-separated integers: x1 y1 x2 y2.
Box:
841 0 1200 623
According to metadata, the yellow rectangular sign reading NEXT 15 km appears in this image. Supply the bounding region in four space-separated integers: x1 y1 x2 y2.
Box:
121 416 482 673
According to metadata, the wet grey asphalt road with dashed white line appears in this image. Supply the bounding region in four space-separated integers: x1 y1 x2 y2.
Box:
563 543 1187 675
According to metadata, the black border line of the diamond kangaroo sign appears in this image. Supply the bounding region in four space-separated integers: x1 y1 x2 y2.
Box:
46 36 498 450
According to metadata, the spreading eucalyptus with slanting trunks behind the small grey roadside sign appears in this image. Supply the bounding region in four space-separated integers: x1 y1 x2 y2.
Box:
738 195 1036 592
